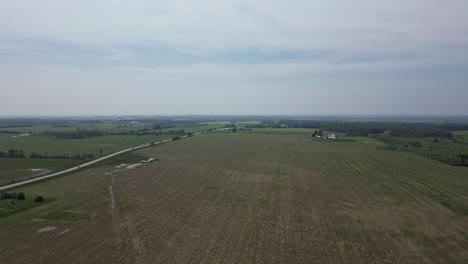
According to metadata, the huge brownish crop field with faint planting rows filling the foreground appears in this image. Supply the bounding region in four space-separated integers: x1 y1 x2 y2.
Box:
0 129 468 263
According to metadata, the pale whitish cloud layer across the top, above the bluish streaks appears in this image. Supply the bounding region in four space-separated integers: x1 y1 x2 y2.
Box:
0 0 468 53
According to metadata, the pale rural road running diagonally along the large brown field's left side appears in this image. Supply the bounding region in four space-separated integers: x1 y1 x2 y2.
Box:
0 132 197 191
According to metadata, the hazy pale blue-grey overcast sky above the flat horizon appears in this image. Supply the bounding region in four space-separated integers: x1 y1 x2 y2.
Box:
0 0 468 116
